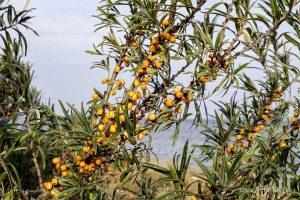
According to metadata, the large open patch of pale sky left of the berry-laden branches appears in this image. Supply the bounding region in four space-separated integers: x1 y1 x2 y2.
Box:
12 0 102 108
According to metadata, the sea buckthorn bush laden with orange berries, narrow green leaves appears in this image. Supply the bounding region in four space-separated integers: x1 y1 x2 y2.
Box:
0 0 300 200
